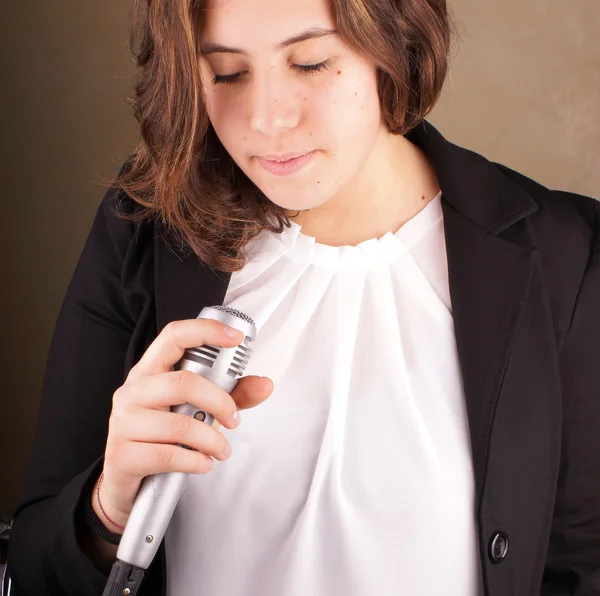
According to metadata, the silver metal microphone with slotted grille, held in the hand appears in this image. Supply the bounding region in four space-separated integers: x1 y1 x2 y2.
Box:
117 306 256 569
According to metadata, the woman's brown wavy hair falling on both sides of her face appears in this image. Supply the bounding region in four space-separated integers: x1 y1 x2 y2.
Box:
103 0 453 272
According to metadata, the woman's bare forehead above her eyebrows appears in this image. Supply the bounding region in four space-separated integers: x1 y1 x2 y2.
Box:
201 0 335 42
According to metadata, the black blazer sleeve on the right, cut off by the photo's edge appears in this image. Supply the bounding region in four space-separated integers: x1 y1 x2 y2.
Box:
542 201 600 596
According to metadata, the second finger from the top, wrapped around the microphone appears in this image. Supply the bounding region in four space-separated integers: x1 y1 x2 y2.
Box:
113 370 239 429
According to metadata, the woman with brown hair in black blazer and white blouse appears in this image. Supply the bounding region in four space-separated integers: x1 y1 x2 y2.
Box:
9 0 600 596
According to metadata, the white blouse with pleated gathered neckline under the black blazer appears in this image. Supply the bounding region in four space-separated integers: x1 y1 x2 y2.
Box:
165 193 483 596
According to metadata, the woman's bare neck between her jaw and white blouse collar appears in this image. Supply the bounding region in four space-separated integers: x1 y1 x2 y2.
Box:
290 125 440 246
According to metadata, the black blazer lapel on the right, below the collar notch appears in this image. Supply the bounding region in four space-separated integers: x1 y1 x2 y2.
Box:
443 203 536 497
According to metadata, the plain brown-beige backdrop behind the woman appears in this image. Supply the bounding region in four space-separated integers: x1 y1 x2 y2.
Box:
0 0 600 516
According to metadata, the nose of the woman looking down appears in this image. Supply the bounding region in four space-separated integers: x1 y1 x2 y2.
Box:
248 72 300 136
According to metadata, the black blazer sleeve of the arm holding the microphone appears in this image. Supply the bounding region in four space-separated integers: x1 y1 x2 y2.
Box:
8 173 165 596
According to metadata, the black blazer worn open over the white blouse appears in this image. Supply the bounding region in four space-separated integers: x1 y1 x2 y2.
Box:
8 123 600 596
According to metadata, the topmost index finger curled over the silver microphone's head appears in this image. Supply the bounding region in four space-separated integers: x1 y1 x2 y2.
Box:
127 319 243 381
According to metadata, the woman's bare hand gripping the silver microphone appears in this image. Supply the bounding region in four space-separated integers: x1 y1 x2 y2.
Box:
100 319 273 532
